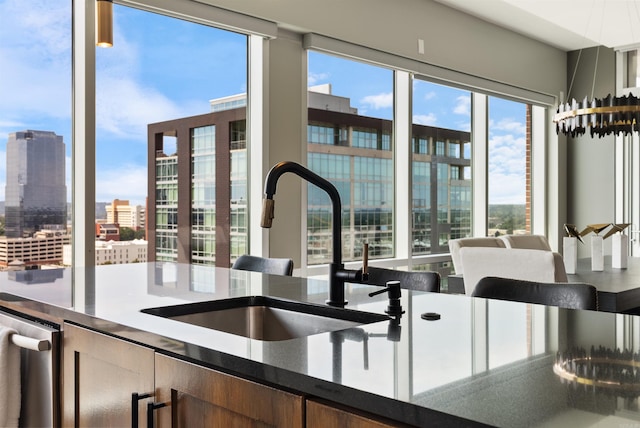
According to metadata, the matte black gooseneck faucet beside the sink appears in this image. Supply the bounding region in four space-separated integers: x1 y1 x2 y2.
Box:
260 161 368 307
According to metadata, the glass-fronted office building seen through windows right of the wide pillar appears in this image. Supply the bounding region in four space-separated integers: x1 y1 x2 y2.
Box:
307 107 471 264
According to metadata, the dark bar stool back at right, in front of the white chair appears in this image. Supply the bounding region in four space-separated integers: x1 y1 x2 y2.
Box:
472 276 598 310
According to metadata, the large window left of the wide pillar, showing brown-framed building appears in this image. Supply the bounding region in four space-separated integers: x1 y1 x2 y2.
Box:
96 5 248 266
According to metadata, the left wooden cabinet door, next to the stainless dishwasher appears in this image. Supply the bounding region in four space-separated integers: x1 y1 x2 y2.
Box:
63 323 154 427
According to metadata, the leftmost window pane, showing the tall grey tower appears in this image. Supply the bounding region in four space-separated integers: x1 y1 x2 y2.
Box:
0 0 72 269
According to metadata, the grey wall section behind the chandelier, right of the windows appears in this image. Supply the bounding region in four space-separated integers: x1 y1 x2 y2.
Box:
566 47 616 257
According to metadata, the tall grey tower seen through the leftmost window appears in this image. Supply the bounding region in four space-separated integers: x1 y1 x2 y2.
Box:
5 130 67 238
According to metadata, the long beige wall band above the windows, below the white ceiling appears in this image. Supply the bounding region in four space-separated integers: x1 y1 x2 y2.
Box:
202 0 566 95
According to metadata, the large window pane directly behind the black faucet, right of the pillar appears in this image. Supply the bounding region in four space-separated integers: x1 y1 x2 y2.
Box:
307 52 394 264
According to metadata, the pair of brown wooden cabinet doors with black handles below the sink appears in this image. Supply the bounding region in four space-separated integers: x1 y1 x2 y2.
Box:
63 323 304 428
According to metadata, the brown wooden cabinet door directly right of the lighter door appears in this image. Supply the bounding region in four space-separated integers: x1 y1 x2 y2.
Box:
155 354 304 428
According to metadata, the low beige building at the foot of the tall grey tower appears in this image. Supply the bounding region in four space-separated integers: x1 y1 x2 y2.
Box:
0 228 70 269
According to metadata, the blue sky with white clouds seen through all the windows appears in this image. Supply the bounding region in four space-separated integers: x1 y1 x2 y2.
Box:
0 0 524 204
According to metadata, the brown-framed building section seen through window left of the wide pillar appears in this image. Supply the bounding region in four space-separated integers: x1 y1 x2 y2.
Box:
146 105 248 267
